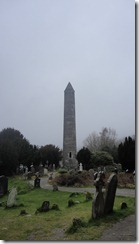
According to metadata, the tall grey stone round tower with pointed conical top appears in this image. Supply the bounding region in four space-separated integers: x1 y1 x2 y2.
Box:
63 82 77 169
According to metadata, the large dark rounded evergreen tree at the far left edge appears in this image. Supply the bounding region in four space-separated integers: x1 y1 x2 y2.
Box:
0 128 30 175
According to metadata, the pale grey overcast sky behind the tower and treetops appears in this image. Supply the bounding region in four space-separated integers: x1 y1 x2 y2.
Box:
0 0 135 148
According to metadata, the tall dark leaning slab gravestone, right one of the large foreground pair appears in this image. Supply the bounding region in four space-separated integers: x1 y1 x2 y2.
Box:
104 173 118 214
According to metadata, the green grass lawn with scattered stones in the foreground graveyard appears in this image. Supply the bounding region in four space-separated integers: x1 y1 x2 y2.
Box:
0 177 135 241
